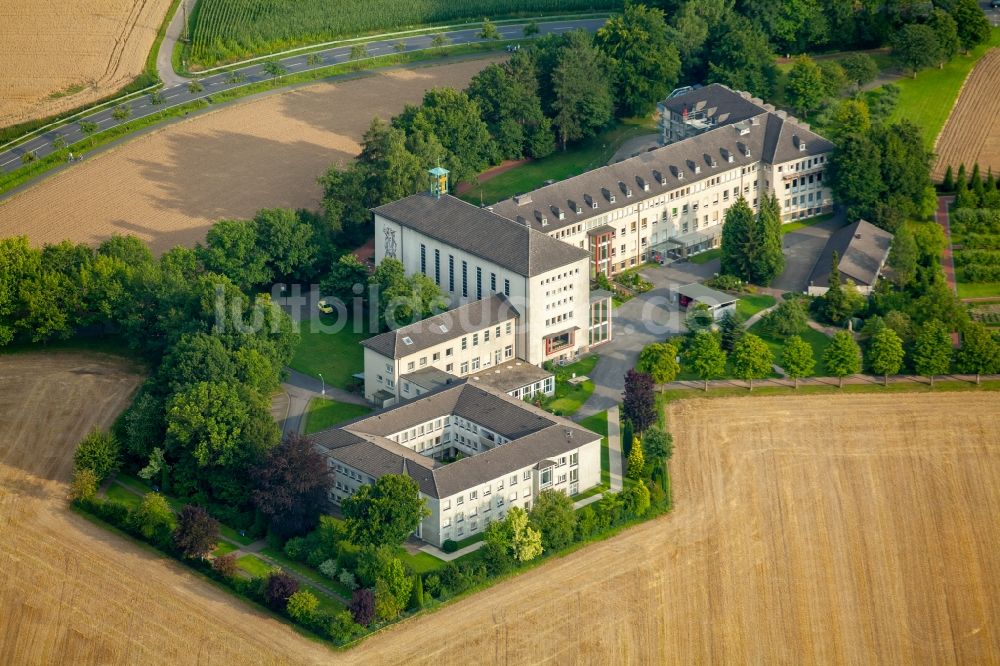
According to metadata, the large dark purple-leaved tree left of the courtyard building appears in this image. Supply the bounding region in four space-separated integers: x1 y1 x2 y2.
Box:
253 434 331 537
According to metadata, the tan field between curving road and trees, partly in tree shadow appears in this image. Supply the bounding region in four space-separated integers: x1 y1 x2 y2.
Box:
0 57 498 253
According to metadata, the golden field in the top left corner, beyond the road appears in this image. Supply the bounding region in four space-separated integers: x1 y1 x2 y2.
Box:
0 0 170 127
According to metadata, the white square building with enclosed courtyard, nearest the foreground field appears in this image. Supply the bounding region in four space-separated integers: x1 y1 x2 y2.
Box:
311 380 601 546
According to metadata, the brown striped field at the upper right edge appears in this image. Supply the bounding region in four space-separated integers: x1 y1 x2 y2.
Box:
934 48 1000 179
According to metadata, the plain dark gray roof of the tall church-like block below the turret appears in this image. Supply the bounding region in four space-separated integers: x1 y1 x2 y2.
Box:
373 194 590 277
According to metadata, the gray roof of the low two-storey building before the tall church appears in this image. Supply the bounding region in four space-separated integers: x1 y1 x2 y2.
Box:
361 294 518 358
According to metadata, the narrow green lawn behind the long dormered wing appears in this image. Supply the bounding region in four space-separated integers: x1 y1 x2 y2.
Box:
461 120 652 204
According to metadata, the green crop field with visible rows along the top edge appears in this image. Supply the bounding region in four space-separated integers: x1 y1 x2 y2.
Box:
188 0 622 67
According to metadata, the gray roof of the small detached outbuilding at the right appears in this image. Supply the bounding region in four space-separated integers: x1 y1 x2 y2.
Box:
809 220 893 287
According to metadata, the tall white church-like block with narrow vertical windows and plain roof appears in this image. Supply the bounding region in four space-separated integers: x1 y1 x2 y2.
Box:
374 187 611 364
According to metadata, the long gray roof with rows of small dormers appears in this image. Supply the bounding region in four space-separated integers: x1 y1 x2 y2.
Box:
490 109 833 232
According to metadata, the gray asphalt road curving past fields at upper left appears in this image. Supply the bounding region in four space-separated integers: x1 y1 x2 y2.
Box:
0 18 604 178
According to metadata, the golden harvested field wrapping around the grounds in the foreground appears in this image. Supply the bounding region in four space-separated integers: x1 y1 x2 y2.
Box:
0 378 1000 666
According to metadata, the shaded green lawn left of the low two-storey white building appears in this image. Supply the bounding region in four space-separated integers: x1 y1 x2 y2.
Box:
289 314 370 388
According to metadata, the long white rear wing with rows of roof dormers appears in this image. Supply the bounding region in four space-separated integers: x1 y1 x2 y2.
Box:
490 84 833 275
